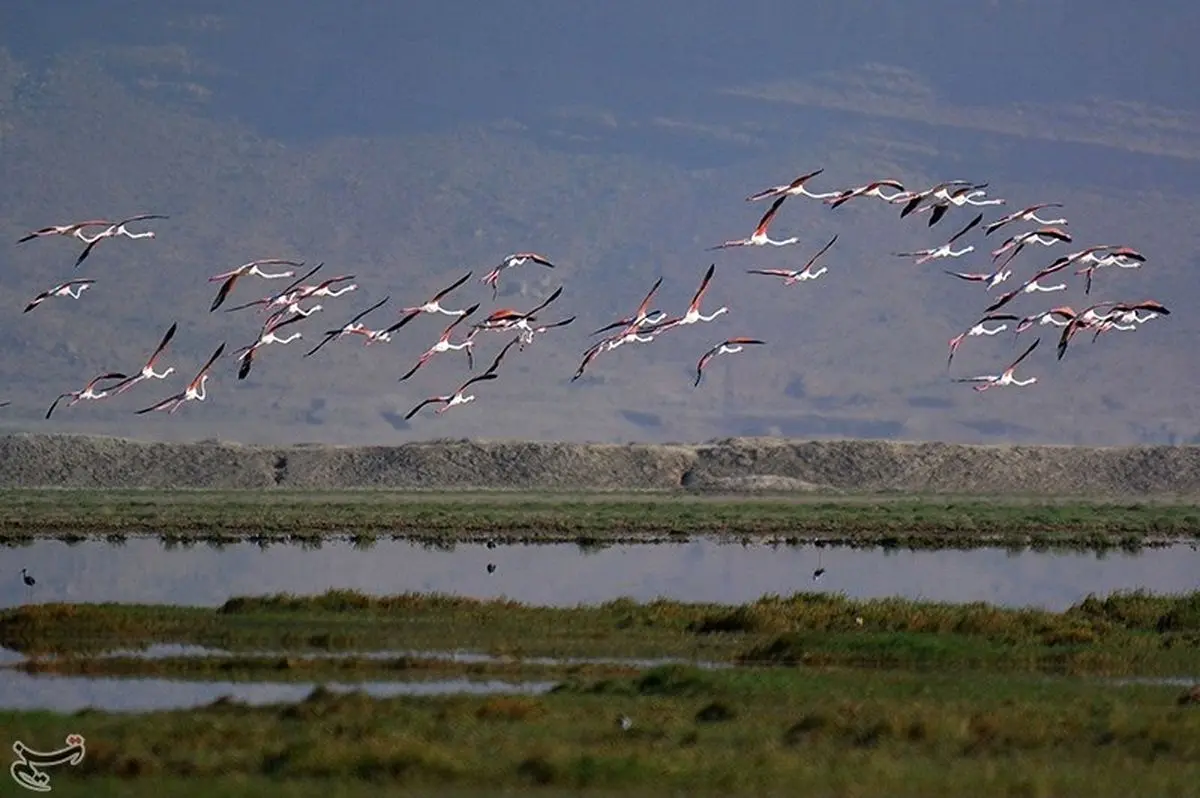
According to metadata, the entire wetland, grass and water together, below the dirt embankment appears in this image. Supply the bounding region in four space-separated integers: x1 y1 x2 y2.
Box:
7 490 1200 798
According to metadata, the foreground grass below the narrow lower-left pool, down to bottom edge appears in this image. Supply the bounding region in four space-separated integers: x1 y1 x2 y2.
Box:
7 666 1200 797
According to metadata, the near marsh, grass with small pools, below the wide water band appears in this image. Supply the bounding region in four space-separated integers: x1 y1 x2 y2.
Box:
0 592 1200 796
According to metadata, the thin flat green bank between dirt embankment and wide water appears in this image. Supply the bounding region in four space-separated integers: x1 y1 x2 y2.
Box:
0 490 1200 547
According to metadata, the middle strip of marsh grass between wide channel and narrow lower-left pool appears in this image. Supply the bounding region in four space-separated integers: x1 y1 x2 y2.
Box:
7 590 1200 676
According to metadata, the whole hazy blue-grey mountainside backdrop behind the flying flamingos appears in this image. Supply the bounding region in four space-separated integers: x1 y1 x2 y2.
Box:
0 0 1200 445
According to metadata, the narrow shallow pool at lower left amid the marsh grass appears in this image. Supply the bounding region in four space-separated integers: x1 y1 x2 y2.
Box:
0 670 557 712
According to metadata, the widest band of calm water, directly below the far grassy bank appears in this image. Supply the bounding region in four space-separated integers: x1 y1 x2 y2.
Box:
0 538 1200 610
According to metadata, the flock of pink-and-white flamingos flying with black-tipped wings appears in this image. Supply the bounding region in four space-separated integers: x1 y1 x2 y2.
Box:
7 160 1170 421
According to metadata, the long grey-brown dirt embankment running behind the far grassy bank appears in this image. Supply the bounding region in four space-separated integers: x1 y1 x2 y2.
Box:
0 434 1200 496
